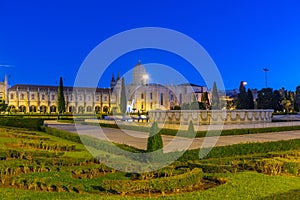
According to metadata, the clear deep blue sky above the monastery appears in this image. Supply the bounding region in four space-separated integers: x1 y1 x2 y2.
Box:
0 0 300 90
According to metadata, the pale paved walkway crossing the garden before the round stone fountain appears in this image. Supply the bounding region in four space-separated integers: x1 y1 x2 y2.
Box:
45 121 300 152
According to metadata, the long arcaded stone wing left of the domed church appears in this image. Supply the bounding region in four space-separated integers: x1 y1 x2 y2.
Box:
8 84 115 113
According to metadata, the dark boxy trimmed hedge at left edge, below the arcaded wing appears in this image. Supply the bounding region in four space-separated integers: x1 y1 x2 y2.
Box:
0 117 44 130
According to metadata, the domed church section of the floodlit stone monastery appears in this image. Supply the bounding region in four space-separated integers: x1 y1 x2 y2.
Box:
120 61 207 111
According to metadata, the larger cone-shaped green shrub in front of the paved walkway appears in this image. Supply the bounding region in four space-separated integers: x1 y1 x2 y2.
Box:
147 122 163 152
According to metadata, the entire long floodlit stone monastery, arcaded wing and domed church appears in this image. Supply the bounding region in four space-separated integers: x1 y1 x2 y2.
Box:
0 61 207 113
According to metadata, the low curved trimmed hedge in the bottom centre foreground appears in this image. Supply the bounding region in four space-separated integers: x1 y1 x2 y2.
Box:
102 168 204 195
